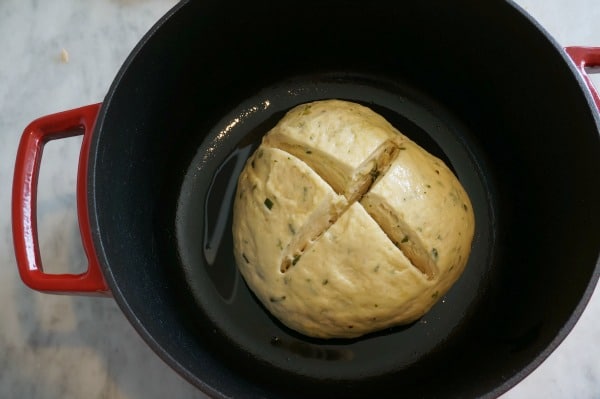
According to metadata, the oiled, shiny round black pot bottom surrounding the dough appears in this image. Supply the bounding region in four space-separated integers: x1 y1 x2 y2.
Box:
169 72 495 379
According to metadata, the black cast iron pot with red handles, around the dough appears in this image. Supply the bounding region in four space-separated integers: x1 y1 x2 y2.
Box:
13 0 600 397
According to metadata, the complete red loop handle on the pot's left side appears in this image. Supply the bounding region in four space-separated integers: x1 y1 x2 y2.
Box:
12 104 110 296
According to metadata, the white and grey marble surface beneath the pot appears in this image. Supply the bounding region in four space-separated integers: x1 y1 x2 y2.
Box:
0 0 600 399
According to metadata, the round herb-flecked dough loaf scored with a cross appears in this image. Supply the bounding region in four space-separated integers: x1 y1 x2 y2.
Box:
233 100 475 338
